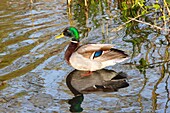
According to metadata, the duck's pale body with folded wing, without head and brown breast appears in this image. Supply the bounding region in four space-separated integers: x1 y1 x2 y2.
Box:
70 44 128 71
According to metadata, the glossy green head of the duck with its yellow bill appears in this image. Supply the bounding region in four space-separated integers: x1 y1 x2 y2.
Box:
55 27 80 41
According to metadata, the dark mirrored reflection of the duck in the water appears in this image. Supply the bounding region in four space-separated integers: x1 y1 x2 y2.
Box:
66 69 129 112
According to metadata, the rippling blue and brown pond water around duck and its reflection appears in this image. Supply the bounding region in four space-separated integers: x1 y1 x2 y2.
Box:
0 0 170 113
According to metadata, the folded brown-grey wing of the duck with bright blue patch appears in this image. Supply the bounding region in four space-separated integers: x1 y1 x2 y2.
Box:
77 44 128 62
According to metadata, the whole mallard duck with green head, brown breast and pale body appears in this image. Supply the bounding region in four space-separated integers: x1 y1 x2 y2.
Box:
56 27 128 72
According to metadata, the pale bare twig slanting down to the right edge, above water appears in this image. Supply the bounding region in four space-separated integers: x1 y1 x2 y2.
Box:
129 17 170 31
